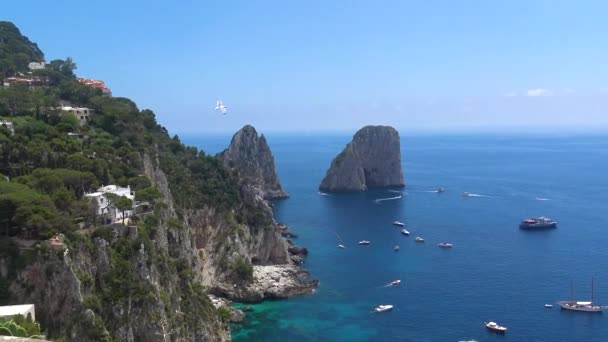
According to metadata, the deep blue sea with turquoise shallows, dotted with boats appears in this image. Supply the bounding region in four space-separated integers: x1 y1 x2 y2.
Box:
184 134 608 342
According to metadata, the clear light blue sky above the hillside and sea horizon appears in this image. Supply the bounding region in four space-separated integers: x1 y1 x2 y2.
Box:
0 0 608 134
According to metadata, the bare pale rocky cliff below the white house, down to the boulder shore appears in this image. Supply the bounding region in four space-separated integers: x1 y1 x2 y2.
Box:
0 150 318 341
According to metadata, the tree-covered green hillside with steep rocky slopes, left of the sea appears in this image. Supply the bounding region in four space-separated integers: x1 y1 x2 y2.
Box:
0 23 280 341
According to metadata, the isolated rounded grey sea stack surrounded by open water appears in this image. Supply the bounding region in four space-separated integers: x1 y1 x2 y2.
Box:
319 126 405 192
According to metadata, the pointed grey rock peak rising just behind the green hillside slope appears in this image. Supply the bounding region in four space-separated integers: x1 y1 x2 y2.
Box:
220 125 288 199
